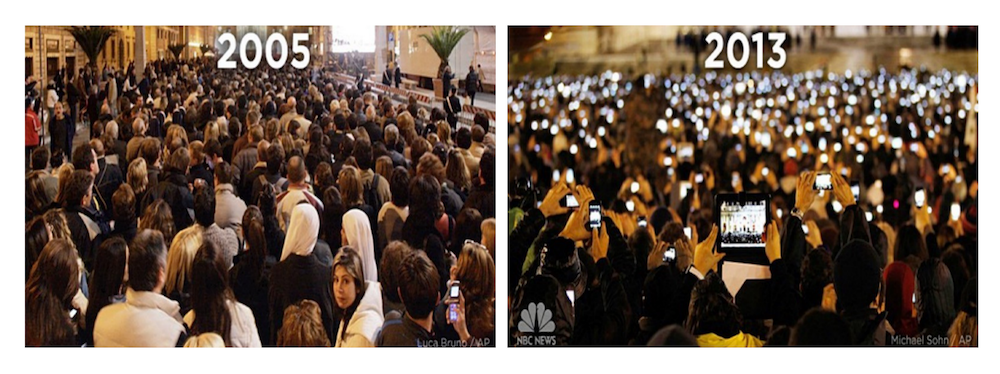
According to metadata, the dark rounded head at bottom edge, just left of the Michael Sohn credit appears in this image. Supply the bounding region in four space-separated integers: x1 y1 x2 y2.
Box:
788 308 854 346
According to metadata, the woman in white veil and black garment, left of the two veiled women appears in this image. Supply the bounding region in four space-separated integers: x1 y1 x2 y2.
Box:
261 203 337 345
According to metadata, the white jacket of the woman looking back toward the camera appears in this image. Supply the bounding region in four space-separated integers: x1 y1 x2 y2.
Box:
334 282 385 347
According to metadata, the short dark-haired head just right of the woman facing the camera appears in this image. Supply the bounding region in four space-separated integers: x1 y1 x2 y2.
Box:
396 251 440 319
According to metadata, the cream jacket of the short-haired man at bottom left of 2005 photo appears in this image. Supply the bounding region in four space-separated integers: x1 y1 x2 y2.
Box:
94 288 184 347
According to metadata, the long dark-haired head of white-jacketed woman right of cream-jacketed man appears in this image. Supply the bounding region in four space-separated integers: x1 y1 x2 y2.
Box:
189 240 234 341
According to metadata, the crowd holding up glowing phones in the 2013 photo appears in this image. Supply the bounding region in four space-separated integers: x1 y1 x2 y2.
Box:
507 68 978 347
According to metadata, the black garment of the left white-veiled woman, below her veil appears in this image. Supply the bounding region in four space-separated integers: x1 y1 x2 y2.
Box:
268 251 338 342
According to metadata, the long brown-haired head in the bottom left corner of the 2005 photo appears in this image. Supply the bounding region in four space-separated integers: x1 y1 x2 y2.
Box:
24 239 80 346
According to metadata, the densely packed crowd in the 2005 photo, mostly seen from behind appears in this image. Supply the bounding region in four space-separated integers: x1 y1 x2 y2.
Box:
25 55 496 347
